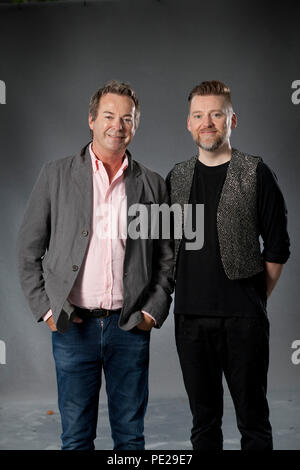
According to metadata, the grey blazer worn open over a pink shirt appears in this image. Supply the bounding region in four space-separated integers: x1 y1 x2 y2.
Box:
17 144 174 332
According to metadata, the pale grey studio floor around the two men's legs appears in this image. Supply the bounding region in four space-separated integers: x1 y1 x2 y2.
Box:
0 392 300 450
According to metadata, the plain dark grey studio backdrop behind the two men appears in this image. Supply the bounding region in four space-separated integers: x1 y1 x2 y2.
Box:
0 0 300 400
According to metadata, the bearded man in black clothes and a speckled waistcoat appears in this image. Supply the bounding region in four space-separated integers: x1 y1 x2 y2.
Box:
167 80 289 450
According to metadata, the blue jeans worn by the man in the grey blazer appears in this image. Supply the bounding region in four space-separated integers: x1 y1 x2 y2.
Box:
52 314 150 450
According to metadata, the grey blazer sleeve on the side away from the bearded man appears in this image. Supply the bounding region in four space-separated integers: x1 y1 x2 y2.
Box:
17 164 51 321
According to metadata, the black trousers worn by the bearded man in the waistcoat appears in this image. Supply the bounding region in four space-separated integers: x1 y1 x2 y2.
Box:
175 315 273 450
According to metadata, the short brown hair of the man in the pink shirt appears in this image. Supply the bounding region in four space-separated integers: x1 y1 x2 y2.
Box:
89 80 140 127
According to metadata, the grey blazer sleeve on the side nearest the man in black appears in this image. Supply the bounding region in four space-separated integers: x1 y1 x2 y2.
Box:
142 178 174 328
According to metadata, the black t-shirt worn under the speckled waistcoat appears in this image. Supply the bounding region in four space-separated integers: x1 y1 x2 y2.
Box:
174 160 289 317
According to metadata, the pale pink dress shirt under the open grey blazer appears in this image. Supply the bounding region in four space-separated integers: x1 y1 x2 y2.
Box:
43 144 155 321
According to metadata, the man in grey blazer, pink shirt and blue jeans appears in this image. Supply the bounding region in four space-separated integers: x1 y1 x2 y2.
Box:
18 81 173 450
